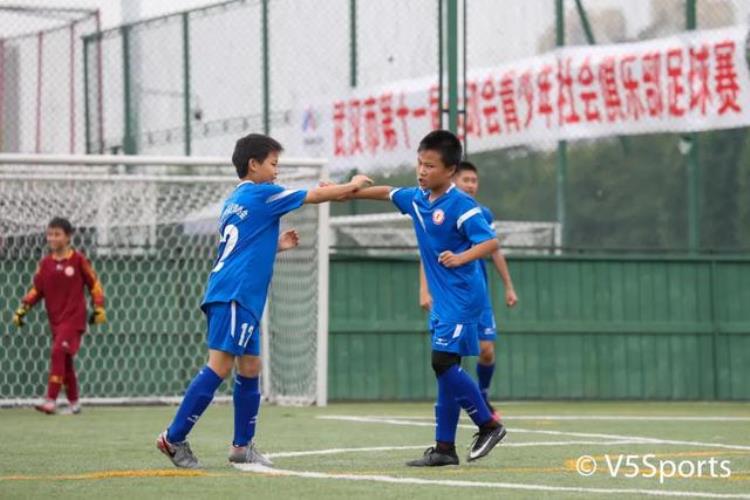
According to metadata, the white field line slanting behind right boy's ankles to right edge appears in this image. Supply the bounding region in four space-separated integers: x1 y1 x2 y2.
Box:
324 415 750 451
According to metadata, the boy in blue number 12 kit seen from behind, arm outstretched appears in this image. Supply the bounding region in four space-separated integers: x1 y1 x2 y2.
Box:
156 134 372 468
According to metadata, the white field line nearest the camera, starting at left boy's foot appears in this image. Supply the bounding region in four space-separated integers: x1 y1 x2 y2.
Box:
234 464 750 499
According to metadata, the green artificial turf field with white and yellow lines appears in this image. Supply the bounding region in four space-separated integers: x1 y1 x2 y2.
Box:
0 402 750 500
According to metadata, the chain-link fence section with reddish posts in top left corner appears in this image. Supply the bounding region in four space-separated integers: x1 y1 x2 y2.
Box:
0 5 99 153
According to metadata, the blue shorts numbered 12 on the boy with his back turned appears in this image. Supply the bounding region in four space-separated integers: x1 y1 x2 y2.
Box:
204 301 260 356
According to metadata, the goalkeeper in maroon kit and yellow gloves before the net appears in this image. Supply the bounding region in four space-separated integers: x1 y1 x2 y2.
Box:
13 217 107 415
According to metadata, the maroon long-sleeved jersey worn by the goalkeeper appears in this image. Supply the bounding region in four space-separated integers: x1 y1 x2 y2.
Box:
23 250 104 331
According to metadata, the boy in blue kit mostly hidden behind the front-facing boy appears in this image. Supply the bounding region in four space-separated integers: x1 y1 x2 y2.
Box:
419 161 518 420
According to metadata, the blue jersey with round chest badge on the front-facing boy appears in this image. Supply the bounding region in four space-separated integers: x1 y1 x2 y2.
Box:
391 186 495 323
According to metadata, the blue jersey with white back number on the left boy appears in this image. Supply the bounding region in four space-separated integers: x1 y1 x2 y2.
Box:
201 181 307 321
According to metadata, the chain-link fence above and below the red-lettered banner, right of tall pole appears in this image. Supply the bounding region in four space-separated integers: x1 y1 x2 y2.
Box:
468 0 750 251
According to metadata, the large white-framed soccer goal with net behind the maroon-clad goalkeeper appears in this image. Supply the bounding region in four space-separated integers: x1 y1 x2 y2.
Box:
0 155 328 405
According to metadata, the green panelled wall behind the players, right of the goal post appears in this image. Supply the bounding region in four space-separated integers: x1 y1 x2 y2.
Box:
329 256 750 400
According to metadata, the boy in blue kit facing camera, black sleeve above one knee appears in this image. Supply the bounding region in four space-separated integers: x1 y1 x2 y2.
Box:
353 130 505 467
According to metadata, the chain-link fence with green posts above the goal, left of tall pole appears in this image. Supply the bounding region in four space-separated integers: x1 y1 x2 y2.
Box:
84 0 438 155
